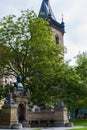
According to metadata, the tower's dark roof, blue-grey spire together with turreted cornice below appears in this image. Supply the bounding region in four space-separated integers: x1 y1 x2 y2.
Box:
38 0 65 34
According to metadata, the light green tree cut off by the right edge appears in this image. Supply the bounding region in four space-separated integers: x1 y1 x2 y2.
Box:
72 52 87 117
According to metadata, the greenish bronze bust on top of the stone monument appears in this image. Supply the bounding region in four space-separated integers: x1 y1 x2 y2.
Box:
14 75 24 95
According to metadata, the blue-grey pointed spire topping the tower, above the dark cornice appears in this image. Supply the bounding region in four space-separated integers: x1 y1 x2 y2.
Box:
38 0 56 20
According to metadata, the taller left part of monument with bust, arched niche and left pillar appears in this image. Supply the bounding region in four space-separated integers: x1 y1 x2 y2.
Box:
0 75 29 129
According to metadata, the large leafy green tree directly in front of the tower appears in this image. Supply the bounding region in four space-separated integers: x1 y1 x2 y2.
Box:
0 10 64 106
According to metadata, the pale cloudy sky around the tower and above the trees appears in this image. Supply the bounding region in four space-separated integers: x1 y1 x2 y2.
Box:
0 0 87 64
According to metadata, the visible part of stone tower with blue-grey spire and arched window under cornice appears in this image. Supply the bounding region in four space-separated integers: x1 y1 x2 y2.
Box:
38 0 65 44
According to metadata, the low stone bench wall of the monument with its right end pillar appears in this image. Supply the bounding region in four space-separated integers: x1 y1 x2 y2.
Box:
28 104 69 127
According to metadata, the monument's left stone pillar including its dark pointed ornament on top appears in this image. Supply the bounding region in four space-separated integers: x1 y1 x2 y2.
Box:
0 92 19 128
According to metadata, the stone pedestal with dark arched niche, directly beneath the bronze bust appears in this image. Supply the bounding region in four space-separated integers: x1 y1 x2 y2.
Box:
13 89 29 124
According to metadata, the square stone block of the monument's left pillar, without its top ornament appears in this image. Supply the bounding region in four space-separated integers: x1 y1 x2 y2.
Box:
0 104 18 128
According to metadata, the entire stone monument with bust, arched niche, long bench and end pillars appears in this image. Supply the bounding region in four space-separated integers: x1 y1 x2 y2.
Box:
0 75 70 128
